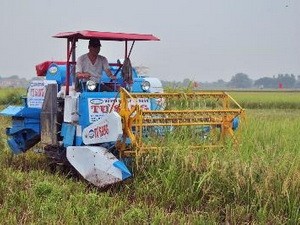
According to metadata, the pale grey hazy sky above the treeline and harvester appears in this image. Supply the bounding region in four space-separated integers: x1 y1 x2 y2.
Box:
0 0 300 82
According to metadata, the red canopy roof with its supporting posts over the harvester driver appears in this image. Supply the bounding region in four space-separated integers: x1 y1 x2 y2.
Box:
53 30 159 95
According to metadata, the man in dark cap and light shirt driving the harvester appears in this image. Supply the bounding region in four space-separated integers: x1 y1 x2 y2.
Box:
76 39 116 91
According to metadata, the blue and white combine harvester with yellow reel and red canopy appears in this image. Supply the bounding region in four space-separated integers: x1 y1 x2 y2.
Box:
0 31 244 187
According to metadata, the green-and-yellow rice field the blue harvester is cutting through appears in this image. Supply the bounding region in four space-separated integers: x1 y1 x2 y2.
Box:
0 88 300 224
